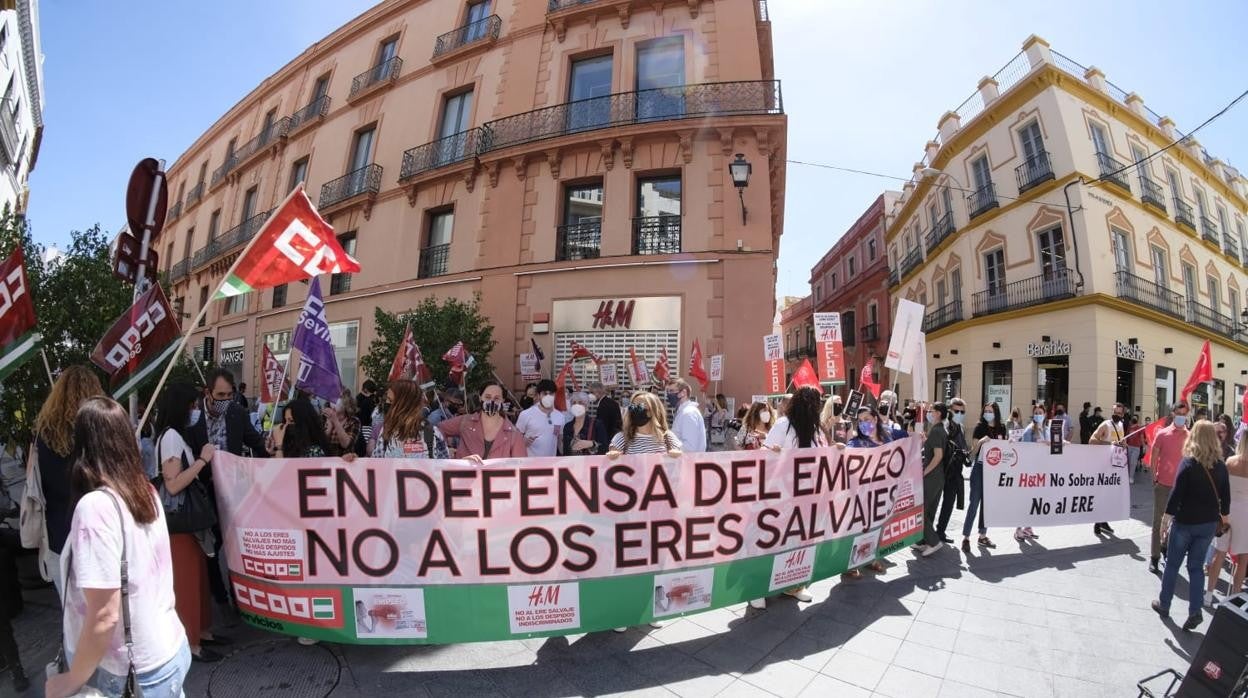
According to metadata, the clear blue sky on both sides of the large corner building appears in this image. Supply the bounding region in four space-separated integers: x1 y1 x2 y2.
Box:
29 0 1248 296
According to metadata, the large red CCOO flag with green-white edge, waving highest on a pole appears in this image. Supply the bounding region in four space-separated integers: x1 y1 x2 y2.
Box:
216 185 359 298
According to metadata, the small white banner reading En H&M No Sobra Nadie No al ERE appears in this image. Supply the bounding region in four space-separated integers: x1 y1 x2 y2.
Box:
982 441 1131 527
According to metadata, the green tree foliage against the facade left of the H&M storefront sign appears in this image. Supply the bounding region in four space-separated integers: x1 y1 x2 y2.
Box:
361 297 495 390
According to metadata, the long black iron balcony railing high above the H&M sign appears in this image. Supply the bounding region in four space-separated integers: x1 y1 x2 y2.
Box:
482 80 784 151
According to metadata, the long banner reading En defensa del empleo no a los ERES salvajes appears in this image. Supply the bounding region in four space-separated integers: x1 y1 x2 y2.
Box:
212 437 922 644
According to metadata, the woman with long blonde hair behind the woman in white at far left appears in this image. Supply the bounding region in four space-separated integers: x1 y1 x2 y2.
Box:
29 366 104 598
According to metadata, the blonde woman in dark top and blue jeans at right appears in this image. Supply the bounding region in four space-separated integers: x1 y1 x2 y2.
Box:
1152 420 1231 631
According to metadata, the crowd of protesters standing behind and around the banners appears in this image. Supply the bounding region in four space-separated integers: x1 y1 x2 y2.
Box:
0 367 1248 697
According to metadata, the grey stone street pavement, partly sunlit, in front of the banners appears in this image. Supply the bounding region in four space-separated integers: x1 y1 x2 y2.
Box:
0 478 1211 698
